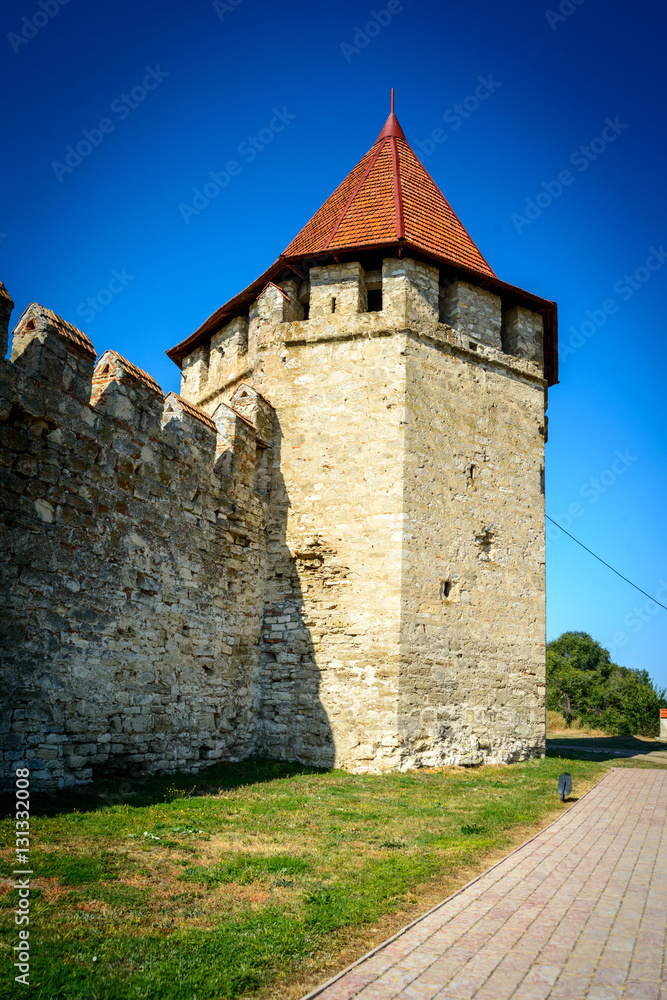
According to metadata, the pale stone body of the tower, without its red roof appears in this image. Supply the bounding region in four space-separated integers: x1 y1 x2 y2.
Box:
192 258 545 770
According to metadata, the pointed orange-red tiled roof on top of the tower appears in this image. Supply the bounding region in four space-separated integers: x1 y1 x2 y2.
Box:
283 111 496 278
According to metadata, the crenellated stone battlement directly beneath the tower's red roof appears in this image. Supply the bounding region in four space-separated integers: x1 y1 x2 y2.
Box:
181 257 545 410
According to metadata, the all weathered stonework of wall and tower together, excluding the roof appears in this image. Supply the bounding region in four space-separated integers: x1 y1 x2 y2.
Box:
0 257 546 787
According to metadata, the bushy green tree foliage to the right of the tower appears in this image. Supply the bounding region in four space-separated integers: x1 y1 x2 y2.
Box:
547 632 667 736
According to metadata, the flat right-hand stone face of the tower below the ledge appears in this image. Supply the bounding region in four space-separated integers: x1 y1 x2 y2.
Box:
399 335 546 766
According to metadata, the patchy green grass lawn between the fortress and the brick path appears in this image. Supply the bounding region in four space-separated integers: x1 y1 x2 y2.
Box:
0 757 664 1000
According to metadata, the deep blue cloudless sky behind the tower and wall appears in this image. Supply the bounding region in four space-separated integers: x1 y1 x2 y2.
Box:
0 0 667 685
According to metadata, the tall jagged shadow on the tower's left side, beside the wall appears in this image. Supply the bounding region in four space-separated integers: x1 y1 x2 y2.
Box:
258 416 335 767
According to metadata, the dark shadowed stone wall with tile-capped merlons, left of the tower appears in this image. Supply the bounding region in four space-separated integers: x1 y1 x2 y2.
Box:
0 290 270 787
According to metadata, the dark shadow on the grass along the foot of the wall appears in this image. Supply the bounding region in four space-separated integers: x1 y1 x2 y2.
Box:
0 757 328 818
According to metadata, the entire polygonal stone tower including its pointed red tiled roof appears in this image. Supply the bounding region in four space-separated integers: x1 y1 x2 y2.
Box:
168 103 557 771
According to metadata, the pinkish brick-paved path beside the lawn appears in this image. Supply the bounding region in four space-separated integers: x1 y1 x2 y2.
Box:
304 768 667 1000
